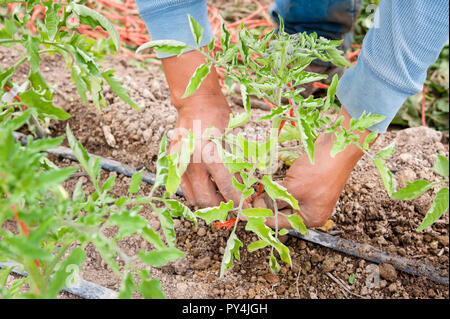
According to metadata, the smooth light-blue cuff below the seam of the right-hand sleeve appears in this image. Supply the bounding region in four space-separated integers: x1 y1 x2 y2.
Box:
336 56 410 133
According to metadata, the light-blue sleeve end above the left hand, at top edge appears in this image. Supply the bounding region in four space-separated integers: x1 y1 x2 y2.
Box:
136 0 214 58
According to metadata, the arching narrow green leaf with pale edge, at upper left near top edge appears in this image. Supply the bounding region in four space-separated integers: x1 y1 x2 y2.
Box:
70 3 120 51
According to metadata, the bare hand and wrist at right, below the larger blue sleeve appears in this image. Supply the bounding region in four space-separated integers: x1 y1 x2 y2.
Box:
253 108 376 228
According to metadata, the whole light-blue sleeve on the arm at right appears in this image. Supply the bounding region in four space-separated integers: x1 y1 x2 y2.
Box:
337 0 449 133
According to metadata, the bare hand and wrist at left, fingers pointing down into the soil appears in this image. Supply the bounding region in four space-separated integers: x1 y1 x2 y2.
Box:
162 51 241 207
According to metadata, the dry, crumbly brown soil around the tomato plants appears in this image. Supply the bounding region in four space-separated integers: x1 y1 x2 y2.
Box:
0 1 449 299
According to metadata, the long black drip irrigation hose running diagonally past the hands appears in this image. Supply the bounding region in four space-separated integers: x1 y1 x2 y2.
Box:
7 133 449 298
